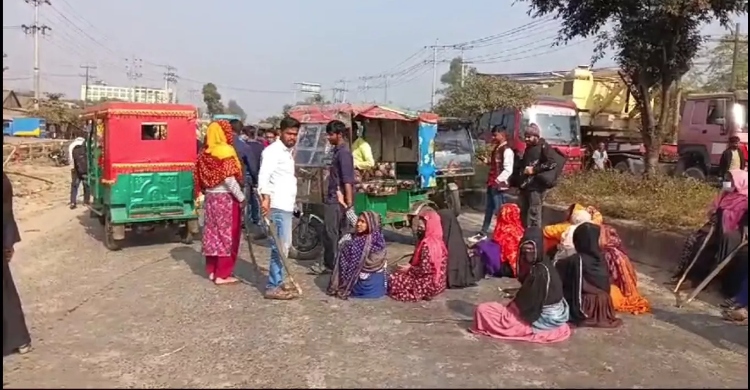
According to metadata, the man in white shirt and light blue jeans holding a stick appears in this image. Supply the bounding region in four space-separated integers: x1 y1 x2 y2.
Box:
258 117 300 300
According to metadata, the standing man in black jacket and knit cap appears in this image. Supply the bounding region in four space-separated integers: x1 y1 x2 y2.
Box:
518 123 557 228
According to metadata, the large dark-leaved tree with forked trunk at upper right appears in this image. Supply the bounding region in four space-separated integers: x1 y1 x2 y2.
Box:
525 0 748 175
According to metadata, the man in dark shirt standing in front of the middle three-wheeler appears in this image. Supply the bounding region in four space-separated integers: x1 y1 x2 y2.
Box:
311 120 354 274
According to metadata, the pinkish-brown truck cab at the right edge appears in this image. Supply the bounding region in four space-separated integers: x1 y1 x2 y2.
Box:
678 90 747 175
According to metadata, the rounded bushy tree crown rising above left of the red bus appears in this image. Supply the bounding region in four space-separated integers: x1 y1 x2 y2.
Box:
435 74 536 118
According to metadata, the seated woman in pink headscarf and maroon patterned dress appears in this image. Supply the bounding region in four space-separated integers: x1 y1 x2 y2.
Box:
388 210 448 302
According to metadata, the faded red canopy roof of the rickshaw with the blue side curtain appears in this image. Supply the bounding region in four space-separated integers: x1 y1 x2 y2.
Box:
288 103 438 123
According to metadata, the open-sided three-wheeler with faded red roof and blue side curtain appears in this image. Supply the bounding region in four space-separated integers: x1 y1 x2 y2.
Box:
288 104 457 259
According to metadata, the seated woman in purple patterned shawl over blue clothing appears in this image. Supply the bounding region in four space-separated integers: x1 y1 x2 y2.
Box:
328 211 386 299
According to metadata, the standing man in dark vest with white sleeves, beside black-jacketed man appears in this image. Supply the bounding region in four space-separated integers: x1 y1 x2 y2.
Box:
474 125 515 241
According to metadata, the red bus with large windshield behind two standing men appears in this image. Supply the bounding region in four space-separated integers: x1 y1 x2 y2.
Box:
478 97 583 172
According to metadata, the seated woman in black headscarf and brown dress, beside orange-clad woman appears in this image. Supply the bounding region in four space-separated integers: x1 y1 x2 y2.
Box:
555 222 622 328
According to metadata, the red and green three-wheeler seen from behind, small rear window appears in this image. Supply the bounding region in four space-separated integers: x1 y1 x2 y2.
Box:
83 102 199 250
